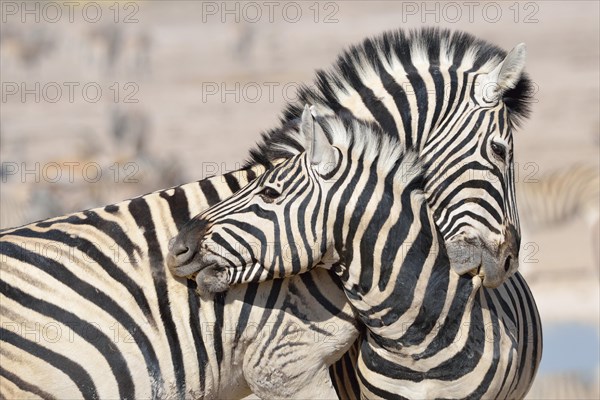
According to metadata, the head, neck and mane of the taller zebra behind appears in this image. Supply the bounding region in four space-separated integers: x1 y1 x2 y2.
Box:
241 28 532 287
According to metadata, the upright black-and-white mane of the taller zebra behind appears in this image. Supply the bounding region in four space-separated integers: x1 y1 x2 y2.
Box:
247 28 533 165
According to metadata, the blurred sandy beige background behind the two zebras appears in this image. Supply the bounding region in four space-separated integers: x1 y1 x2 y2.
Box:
0 1 600 399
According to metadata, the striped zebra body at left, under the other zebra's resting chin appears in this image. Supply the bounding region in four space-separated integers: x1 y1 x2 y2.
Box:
0 165 366 399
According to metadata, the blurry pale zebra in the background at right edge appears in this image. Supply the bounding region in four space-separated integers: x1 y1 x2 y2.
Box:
516 164 600 275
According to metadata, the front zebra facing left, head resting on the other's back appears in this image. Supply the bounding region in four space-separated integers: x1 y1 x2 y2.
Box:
167 106 542 399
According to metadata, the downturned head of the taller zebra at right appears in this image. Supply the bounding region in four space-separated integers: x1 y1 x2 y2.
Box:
421 44 528 287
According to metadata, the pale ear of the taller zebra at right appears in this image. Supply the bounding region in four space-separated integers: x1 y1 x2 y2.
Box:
480 43 527 102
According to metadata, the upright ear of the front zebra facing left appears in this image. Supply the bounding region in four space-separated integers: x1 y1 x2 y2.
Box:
300 104 336 170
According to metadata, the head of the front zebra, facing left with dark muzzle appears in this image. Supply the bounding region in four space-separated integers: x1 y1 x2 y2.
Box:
167 107 428 293
